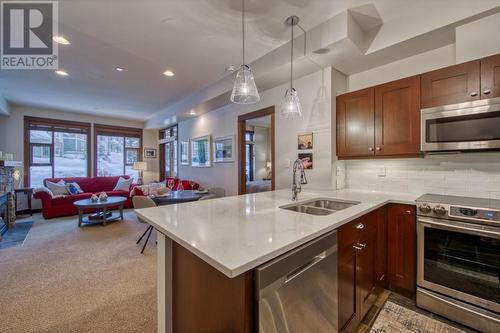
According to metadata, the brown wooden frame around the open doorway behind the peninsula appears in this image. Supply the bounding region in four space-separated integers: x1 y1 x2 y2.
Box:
238 105 276 194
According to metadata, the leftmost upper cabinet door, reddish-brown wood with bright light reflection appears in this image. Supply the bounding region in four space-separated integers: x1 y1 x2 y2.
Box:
337 88 375 157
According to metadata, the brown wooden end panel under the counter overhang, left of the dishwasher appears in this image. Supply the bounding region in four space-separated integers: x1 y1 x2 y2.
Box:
172 242 254 333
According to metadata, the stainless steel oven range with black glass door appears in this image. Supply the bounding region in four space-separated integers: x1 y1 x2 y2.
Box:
417 195 500 332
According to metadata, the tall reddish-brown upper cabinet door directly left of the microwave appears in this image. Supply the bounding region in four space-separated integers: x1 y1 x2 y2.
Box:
375 76 420 155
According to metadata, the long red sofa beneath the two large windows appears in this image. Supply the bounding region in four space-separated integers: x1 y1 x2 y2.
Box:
33 176 135 219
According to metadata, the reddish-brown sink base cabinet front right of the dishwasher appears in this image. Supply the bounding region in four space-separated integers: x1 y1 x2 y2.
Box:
338 209 384 332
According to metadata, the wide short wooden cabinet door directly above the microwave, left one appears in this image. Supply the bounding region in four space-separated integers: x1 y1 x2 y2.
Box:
422 60 480 108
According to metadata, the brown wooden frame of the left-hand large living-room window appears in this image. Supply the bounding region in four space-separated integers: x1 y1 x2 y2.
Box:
24 116 91 187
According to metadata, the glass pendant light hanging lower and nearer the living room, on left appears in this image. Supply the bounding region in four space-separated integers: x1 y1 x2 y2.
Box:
231 0 260 104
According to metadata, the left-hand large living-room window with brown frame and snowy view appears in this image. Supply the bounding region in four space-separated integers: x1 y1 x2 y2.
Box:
24 117 90 187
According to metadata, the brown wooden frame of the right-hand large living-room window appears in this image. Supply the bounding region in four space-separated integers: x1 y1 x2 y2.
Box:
94 124 144 176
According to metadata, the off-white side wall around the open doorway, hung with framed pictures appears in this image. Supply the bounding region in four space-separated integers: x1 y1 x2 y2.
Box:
179 68 331 195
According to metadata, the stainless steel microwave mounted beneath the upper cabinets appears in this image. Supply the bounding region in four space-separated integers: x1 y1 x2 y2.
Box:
420 98 500 152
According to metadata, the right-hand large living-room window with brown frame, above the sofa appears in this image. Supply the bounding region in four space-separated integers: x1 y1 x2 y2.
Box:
94 125 142 180
